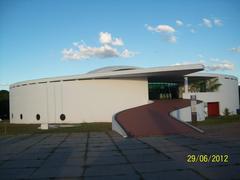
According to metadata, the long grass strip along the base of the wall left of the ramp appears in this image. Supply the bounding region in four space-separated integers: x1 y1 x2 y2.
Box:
0 122 112 136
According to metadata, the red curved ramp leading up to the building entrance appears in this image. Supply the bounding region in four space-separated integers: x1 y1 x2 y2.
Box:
116 99 195 137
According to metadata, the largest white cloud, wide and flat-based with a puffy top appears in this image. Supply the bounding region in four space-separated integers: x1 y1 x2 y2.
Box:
62 32 137 60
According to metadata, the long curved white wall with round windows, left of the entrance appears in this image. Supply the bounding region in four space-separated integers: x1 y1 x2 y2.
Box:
10 79 148 123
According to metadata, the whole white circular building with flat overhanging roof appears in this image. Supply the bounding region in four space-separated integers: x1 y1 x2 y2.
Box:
10 64 239 124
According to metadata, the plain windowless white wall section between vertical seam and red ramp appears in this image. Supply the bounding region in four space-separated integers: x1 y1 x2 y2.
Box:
62 79 148 122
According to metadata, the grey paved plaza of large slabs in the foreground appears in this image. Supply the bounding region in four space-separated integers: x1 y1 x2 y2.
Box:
0 132 240 180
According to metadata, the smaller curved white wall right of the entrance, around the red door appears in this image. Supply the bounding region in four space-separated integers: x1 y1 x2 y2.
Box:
183 73 239 115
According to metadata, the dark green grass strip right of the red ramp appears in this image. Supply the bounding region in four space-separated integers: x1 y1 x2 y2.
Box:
197 115 240 125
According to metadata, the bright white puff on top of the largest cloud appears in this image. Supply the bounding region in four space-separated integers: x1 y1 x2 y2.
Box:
99 32 123 46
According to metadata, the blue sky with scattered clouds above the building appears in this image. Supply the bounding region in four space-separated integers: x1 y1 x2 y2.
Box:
0 0 240 89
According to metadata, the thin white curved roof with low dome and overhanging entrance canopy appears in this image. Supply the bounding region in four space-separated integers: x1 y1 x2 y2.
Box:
10 64 204 88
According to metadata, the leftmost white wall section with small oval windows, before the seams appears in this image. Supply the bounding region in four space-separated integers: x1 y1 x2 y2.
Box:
10 84 47 123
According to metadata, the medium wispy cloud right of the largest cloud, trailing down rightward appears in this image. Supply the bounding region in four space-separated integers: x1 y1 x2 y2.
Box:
145 24 177 43
